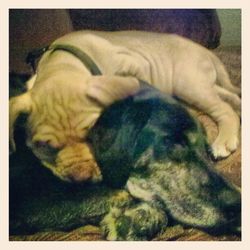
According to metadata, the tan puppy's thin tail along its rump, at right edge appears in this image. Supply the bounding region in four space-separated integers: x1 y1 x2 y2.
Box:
211 53 241 95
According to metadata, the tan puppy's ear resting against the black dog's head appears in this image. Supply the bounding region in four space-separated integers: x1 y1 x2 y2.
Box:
87 76 140 106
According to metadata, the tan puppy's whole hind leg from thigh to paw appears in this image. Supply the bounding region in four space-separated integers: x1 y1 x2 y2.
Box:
173 57 240 159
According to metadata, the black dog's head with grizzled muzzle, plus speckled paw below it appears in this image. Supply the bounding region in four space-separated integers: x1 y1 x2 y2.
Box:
88 87 241 240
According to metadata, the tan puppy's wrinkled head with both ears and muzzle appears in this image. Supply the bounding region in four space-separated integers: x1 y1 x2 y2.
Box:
9 72 139 182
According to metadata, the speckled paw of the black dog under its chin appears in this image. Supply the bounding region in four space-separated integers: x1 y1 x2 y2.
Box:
101 203 168 241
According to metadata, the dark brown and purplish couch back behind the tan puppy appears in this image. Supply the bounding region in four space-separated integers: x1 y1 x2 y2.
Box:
9 9 221 73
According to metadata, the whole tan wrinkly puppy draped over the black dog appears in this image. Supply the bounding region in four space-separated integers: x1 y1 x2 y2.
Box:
10 31 241 181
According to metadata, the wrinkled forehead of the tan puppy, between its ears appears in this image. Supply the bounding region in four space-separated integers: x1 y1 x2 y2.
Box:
28 81 101 144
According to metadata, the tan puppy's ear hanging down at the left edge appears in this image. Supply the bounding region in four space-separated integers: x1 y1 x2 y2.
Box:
9 92 31 153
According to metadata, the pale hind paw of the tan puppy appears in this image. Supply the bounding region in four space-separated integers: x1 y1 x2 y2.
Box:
212 135 239 159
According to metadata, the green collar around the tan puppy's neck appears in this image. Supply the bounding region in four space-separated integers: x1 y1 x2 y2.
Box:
26 44 102 75
